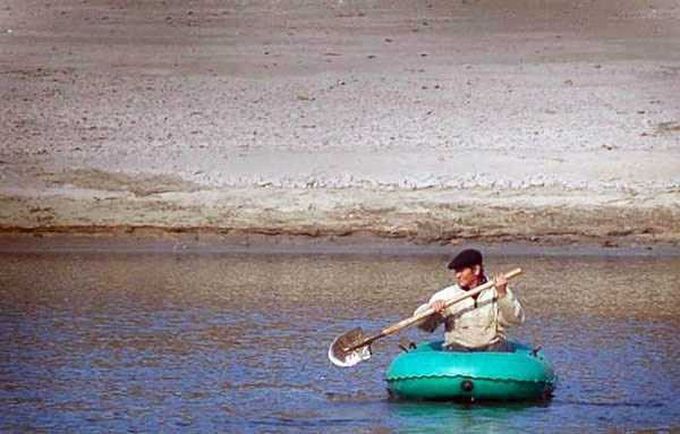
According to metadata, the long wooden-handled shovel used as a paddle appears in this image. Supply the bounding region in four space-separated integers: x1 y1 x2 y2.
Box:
328 268 522 368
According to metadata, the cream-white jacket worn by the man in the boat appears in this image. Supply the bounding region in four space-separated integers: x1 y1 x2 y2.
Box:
415 285 524 348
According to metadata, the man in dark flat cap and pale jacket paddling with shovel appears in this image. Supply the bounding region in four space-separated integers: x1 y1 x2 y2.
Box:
415 249 524 351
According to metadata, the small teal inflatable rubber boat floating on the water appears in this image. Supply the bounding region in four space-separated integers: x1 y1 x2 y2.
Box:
386 341 557 402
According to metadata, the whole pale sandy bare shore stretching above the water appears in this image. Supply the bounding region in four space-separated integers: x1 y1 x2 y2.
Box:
0 0 680 246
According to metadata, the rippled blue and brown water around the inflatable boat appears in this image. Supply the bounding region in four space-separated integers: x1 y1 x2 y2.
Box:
0 246 680 432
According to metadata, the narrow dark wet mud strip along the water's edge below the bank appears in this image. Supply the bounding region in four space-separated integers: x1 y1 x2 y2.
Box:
0 228 680 259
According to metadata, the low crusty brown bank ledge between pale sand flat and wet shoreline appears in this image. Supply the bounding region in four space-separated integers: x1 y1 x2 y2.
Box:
0 189 680 246
